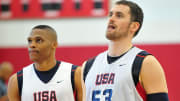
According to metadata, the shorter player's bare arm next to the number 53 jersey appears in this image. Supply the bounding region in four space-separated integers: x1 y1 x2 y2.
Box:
75 67 85 101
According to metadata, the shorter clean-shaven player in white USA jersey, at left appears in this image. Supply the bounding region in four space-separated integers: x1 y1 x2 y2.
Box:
8 25 83 101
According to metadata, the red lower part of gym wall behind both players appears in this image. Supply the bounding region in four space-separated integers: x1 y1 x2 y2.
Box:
0 44 180 101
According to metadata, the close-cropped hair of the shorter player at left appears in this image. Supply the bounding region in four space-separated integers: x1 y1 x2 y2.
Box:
32 25 57 40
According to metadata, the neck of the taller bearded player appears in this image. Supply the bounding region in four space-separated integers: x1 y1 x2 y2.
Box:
108 40 133 56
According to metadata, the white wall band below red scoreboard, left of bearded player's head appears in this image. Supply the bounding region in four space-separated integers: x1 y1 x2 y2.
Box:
0 18 106 46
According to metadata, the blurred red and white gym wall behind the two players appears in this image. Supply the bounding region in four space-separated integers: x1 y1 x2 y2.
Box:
0 0 180 101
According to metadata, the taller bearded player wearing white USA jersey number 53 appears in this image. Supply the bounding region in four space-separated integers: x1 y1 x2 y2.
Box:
83 0 168 101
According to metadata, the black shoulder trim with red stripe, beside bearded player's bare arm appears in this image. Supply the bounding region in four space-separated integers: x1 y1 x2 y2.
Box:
132 51 151 86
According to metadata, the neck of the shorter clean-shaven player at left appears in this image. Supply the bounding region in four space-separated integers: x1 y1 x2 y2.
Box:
34 58 56 71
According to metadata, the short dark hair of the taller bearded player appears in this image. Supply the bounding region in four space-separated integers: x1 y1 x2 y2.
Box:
115 0 144 37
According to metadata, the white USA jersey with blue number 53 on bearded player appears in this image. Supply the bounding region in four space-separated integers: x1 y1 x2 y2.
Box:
85 47 149 101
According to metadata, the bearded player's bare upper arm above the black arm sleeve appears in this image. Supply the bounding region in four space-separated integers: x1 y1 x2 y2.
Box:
140 55 168 94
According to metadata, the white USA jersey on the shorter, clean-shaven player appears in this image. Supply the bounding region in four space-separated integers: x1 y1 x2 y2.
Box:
21 62 75 101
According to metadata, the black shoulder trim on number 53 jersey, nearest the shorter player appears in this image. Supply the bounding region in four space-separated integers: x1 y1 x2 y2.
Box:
83 57 96 82
